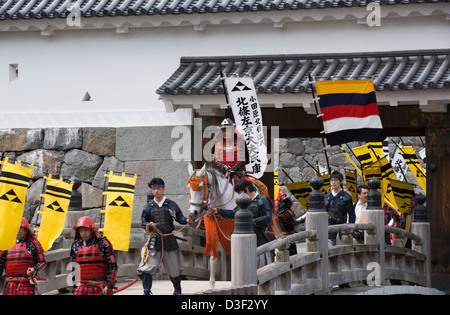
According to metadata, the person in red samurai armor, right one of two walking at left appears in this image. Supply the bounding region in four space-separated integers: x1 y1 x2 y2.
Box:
70 217 117 295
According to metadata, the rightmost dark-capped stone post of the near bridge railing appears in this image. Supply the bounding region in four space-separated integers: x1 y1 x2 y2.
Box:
411 193 431 287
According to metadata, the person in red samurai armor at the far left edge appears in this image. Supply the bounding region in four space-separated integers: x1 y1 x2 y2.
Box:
0 218 47 295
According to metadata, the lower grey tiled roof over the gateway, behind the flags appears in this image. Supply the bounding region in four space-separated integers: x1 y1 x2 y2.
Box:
156 50 450 95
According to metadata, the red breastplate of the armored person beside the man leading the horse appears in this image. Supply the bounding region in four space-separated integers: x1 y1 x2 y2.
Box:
75 244 108 281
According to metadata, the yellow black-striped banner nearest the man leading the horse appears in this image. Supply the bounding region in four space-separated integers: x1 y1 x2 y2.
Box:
101 171 137 251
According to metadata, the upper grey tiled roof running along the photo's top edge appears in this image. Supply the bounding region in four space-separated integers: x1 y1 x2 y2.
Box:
0 0 446 20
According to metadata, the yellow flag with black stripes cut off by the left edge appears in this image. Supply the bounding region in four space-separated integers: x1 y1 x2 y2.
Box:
0 158 34 250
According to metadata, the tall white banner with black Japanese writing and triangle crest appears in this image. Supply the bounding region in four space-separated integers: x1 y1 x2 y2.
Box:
224 76 268 178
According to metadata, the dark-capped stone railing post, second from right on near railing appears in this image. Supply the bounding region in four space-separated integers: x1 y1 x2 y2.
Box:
364 177 386 285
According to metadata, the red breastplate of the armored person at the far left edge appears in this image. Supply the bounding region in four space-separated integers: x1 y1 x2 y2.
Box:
5 242 34 277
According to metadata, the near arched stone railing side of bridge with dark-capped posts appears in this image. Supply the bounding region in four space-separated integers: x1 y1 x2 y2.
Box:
209 177 443 295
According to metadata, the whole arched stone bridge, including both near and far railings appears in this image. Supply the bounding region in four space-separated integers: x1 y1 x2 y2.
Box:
0 178 442 295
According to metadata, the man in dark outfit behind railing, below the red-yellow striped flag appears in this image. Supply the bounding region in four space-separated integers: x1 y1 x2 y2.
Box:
325 171 355 245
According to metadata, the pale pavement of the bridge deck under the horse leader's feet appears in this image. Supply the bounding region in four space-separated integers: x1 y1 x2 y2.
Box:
116 280 231 295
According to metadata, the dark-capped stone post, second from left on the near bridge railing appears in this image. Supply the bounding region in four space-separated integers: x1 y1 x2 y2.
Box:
306 176 329 294
